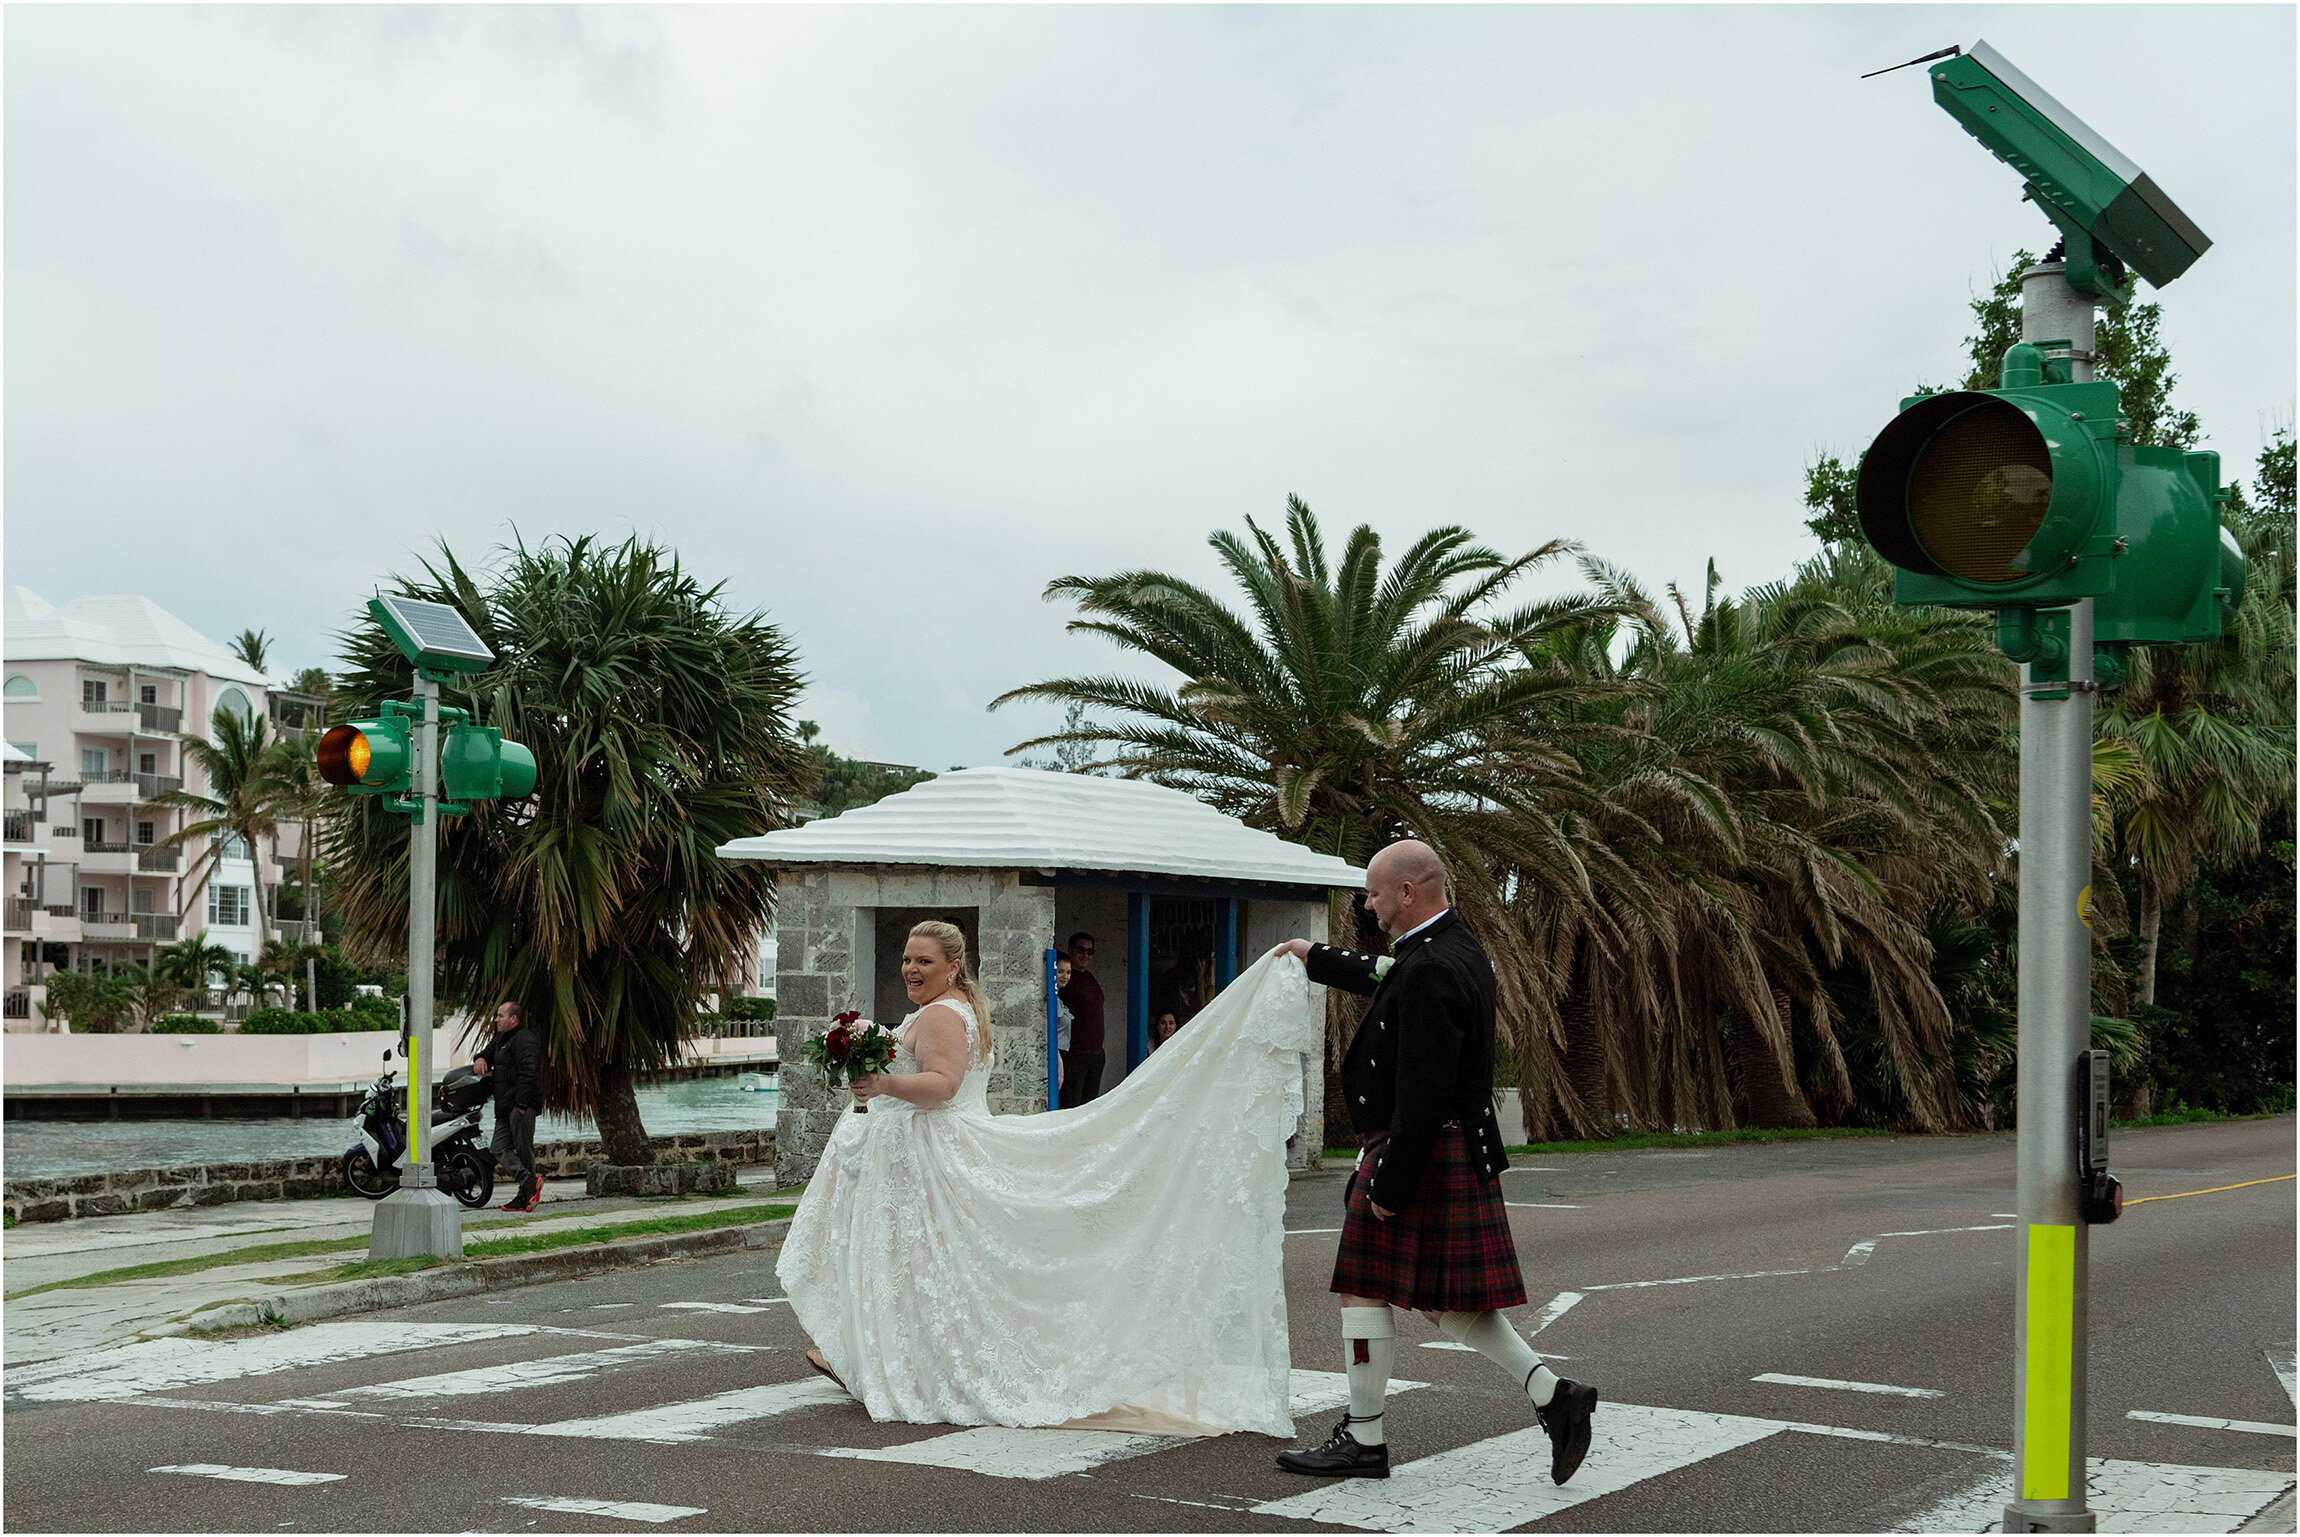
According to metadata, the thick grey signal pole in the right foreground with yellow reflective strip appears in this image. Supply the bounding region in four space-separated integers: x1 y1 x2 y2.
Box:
2006 262 2095 1532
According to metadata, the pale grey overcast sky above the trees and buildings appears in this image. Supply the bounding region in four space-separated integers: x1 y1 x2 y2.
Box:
5 5 2295 769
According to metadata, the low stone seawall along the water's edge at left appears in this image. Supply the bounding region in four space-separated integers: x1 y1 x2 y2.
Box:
0 1130 775 1222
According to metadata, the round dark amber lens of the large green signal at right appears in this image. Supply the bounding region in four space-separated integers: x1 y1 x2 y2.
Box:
1909 400 2052 582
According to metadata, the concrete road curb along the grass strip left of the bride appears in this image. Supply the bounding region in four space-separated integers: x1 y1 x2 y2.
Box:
162 1217 791 1335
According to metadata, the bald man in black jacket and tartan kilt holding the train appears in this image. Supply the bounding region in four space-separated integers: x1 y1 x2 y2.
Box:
1279 842 1596 1484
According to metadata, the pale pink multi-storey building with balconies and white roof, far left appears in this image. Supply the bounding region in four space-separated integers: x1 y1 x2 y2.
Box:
0 587 320 1031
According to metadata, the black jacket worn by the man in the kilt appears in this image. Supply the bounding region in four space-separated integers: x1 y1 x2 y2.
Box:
1309 909 1509 1213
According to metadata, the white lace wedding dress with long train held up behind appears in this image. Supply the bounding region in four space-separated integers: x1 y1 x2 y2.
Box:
775 957 1323 1436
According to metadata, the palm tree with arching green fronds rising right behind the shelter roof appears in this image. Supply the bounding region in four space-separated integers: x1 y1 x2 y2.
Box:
991 497 1615 1136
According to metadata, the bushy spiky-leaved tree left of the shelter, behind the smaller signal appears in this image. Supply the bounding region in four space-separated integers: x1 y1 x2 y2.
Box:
327 538 807 1164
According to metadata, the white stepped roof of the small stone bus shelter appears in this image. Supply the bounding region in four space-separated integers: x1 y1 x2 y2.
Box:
720 769 1366 890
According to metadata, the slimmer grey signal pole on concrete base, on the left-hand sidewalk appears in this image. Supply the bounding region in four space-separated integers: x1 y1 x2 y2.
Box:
368 667 462 1259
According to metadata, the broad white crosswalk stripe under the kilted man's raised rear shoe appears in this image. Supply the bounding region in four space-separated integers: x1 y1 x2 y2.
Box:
1254 1404 1780 1532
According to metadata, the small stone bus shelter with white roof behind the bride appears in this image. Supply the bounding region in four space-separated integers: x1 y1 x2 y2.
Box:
720 769 1366 1185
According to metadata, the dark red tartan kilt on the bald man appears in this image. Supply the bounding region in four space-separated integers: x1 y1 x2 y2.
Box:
1332 1125 1525 1314
